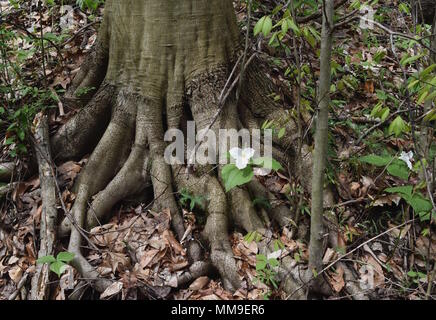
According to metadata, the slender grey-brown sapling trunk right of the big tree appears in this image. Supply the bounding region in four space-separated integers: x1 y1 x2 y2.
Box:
309 0 334 291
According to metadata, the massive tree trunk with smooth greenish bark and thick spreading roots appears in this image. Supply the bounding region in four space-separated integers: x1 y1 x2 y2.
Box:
52 0 310 298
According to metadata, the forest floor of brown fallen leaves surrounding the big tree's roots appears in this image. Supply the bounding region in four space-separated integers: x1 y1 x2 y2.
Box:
0 0 436 300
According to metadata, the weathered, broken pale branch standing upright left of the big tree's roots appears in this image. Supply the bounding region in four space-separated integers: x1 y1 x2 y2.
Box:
30 114 57 300
